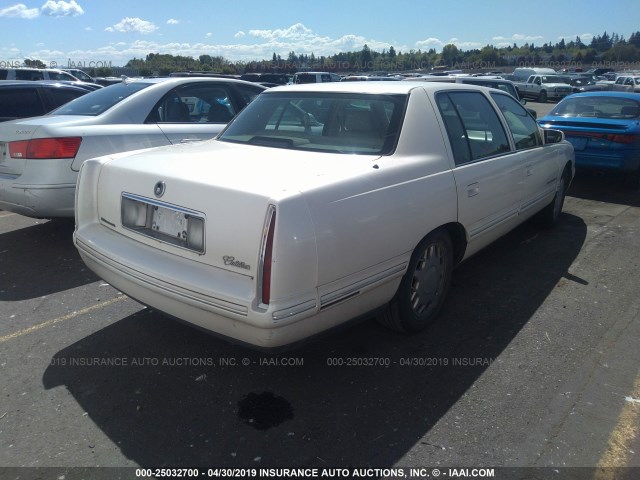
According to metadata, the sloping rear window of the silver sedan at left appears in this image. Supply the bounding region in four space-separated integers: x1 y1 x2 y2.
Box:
51 82 153 116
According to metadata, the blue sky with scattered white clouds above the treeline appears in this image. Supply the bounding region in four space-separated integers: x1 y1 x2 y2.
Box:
0 0 640 68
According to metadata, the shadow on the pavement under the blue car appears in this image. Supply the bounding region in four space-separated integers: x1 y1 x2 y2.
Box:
567 171 640 207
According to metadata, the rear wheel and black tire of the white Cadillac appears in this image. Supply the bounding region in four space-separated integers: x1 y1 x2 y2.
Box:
378 230 453 333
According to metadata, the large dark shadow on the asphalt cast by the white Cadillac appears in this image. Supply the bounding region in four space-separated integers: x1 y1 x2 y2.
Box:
42 214 587 468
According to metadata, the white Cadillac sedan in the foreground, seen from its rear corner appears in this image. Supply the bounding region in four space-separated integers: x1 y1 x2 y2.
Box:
74 82 574 348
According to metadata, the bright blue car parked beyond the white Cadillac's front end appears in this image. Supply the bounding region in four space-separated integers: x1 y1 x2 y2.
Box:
538 92 640 187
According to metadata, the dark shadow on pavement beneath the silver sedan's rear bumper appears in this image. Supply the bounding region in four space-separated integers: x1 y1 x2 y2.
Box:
0 220 99 301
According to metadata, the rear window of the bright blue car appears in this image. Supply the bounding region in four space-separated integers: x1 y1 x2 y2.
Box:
549 96 640 120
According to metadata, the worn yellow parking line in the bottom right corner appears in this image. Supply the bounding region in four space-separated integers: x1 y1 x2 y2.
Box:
594 374 640 480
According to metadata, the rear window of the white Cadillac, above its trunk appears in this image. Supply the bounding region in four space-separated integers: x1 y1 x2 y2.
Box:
218 92 407 155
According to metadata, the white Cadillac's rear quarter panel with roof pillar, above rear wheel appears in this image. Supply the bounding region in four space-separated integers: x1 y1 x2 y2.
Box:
305 88 457 295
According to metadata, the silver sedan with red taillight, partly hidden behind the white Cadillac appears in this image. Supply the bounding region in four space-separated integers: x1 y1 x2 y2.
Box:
0 77 265 218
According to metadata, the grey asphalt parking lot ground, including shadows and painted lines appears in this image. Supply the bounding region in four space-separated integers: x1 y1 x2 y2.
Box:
0 102 640 479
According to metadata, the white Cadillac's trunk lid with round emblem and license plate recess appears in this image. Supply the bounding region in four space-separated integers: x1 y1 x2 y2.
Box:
97 141 380 276
